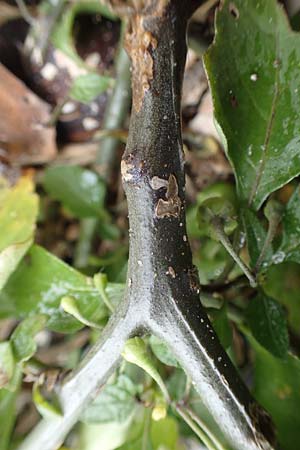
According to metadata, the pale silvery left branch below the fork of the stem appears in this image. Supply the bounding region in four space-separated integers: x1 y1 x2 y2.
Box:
18 307 136 450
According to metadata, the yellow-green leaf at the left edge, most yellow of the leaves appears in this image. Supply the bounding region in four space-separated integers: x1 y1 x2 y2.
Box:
0 177 38 289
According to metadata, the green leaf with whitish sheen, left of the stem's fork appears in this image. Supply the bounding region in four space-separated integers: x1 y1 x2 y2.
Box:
0 245 108 333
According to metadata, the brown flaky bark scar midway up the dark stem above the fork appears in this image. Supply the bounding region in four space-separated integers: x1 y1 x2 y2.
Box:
152 174 181 219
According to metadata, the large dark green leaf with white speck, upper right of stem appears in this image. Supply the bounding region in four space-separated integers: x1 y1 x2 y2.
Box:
205 0 300 209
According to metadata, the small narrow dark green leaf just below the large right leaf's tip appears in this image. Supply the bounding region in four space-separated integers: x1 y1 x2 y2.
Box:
241 208 273 268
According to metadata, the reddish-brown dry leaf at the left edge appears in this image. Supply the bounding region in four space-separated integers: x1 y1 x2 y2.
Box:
0 65 57 165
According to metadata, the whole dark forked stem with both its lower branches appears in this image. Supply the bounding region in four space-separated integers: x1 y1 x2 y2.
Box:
19 0 273 450
